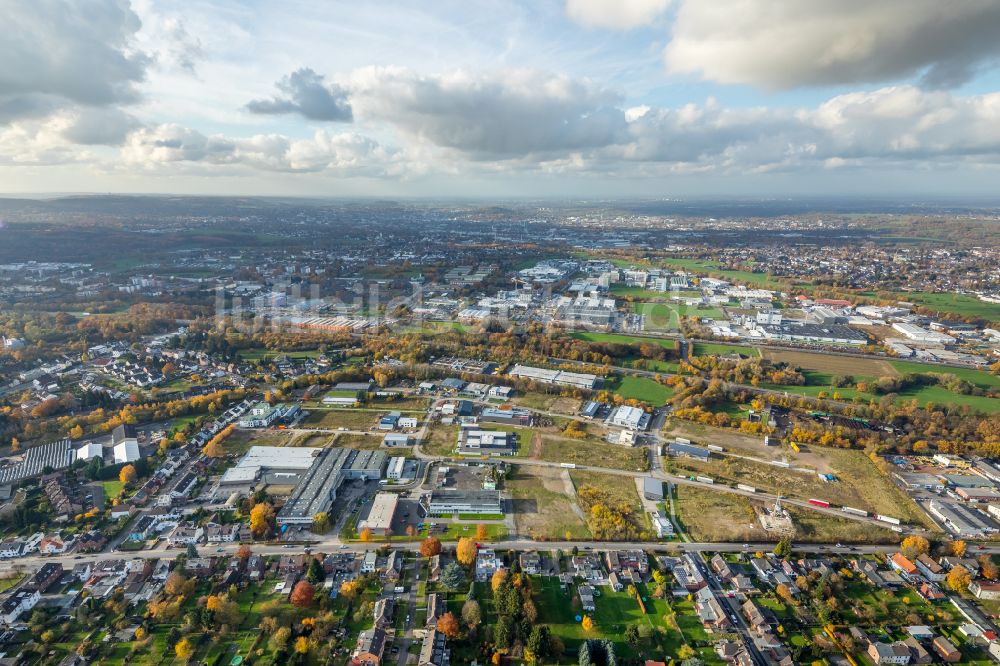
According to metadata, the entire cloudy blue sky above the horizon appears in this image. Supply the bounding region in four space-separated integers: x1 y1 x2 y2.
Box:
0 0 1000 198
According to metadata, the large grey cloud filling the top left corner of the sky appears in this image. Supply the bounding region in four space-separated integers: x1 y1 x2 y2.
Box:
0 0 148 122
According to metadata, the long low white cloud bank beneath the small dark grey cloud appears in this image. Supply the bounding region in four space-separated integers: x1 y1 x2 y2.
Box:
121 124 395 176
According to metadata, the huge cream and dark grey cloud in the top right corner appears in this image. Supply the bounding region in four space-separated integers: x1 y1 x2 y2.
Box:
664 0 1000 89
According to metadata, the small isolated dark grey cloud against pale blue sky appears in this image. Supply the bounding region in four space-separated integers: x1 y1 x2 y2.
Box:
246 67 353 122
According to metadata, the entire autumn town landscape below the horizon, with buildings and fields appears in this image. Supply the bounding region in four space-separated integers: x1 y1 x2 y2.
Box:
0 197 1000 666
